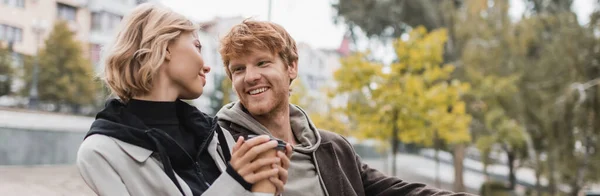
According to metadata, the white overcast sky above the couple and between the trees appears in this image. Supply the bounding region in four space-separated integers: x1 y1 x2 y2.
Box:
161 0 596 49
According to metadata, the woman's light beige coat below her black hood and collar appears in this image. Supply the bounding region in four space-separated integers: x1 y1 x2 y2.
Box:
77 130 253 196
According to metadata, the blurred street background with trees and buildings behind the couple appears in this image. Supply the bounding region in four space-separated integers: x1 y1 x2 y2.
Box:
0 0 600 196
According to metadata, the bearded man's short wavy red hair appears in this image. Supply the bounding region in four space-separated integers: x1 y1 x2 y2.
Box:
219 19 298 79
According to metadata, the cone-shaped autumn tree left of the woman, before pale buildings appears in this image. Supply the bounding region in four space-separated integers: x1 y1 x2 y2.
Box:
23 21 99 110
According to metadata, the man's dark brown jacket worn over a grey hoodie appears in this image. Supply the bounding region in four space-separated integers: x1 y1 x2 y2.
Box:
220 123 470 196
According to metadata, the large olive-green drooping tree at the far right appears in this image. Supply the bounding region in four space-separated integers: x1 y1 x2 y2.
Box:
456 2 599 195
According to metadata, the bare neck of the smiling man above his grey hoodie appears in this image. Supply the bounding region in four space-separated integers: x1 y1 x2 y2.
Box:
254 104 296 145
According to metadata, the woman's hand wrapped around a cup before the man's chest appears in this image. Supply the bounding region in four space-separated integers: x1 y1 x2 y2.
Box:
230 135 289 184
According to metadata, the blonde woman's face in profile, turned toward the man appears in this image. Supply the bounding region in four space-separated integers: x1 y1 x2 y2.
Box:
162 32 210 99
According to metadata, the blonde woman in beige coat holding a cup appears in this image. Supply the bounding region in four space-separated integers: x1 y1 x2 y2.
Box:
77 3 291 196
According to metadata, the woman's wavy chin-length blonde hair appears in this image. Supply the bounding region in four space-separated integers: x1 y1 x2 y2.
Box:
102 3 198 102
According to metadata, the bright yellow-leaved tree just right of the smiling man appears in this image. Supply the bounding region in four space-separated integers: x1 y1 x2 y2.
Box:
334 27 471 181
